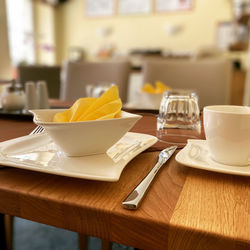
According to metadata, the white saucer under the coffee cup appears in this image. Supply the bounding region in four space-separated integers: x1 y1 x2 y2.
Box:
175 140 250 176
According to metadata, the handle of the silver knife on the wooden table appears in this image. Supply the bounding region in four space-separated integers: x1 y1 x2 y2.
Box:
122 162 164 210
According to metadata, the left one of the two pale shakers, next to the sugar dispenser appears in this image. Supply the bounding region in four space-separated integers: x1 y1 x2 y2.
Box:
25 81 38 110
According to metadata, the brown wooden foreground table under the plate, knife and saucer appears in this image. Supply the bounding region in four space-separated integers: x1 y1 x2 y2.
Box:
0 115 250 250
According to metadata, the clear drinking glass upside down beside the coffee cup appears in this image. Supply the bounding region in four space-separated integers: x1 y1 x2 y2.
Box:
156 90 201 146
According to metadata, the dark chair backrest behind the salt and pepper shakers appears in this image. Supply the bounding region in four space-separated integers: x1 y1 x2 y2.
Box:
17 65 61 99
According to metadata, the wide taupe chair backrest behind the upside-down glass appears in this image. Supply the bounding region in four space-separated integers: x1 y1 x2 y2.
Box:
143 58 232 108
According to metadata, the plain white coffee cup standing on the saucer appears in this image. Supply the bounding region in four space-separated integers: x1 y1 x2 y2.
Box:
203 105 250 166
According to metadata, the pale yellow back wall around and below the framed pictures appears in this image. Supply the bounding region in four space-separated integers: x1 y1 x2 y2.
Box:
56 0 232 61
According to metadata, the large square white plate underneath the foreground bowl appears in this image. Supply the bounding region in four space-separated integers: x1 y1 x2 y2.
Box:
0 132 157 181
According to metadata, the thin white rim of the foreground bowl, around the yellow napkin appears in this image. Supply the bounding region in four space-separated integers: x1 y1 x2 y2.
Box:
30 109 142 126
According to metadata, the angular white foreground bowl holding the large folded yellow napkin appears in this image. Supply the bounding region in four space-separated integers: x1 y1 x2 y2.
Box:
30 109 142 156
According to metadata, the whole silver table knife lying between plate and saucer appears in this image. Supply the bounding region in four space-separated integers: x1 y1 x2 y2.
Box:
122 146 177 210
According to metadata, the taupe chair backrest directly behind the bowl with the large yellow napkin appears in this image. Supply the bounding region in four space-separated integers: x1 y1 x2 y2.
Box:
60 61 130 102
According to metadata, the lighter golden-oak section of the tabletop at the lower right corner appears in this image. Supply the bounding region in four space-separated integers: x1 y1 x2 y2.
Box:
169 169 250 250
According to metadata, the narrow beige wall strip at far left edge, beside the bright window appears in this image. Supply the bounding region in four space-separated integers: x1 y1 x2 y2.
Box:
0 0 11 79
